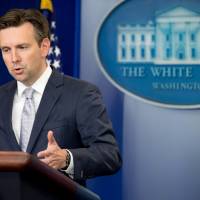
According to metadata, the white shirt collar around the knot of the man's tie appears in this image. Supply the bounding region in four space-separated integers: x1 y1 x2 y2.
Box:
17 66 52 97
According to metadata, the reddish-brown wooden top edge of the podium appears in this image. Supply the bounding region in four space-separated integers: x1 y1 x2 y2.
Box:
0 151 100 200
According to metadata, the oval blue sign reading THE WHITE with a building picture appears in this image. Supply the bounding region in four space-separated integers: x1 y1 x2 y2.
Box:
97 0 200 108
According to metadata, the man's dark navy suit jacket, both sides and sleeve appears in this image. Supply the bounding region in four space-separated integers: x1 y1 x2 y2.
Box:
0 70 121 184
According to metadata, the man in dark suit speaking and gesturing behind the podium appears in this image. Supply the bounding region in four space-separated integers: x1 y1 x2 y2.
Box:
0 9 121 184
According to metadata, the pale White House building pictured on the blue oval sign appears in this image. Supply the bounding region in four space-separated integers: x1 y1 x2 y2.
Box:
117 7 200 64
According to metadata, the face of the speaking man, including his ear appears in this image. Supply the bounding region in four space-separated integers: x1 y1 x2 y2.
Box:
0 22 50 86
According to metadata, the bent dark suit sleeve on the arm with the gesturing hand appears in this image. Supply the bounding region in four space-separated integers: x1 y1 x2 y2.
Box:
70 84 121 180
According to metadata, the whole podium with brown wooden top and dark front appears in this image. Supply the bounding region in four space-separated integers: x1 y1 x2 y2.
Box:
0 151 100 200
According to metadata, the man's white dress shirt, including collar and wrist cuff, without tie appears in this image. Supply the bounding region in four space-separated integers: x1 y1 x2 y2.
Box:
12 66 74 176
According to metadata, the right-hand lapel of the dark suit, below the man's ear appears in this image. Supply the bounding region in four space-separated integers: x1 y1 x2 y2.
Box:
27 70 63 153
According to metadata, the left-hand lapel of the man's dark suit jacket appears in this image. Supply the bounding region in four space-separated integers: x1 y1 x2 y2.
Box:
3 81 21 151
